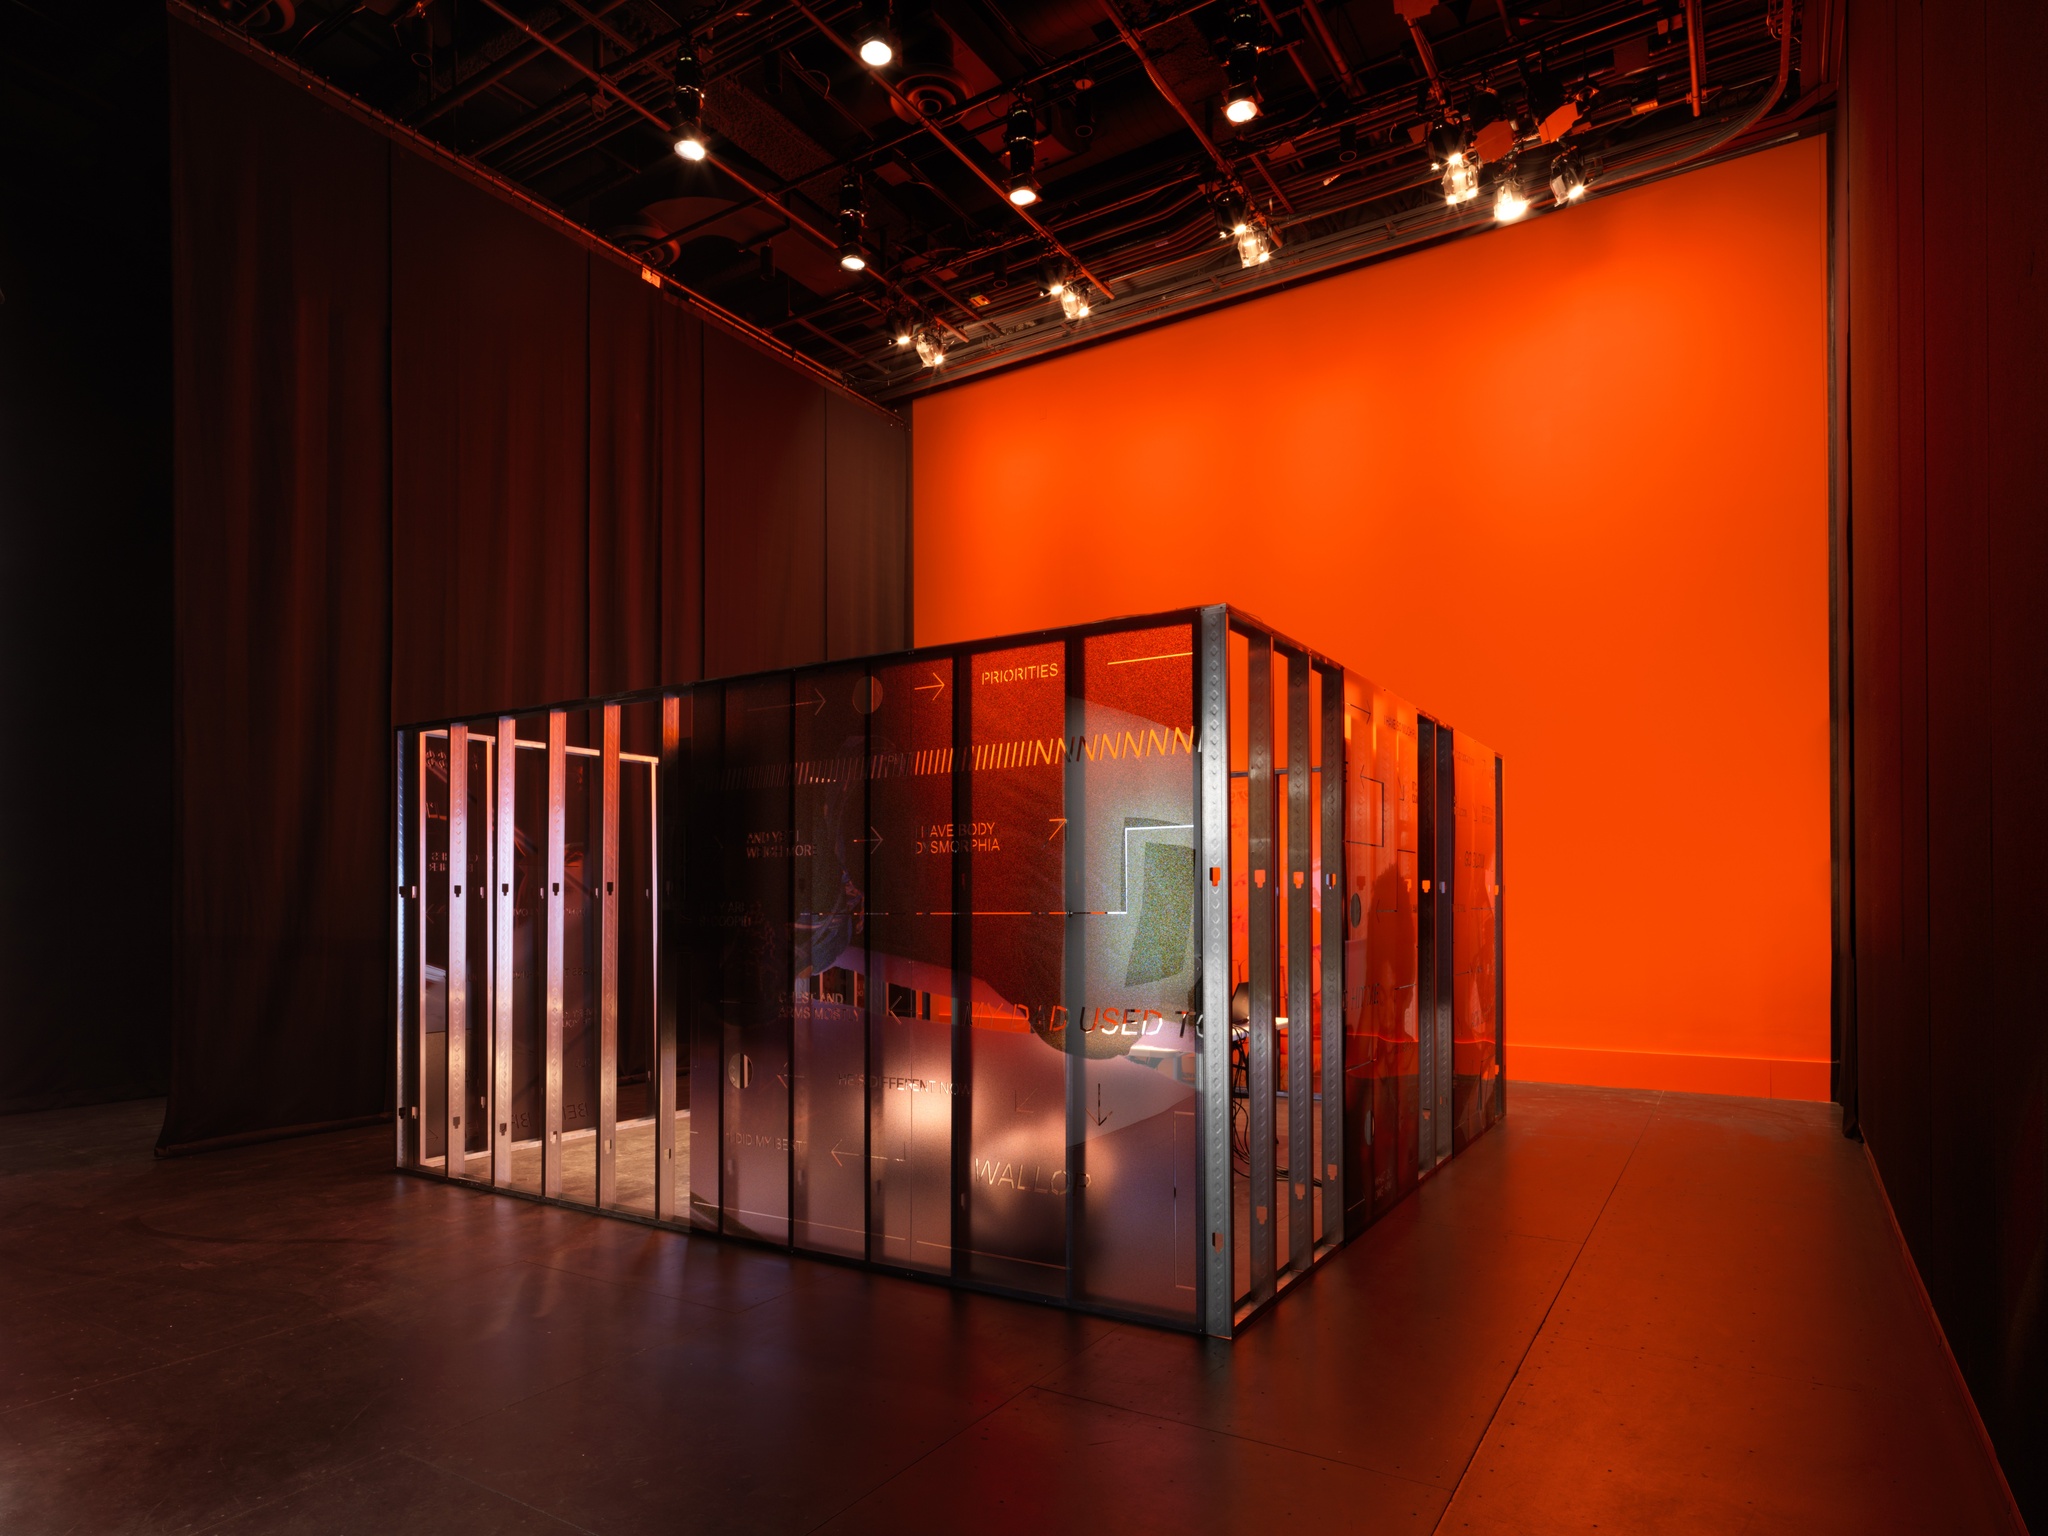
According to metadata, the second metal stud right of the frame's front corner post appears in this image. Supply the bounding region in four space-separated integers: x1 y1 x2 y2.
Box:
1286 651 1315 1274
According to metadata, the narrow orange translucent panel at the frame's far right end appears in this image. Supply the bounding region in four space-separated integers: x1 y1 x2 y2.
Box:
1450 731 1501 1149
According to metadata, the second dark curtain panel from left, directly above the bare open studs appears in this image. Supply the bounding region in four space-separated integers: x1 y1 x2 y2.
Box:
391 156 590 721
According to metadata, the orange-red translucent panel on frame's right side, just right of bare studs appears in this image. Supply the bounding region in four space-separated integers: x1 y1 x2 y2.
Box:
1343 676 1421 1231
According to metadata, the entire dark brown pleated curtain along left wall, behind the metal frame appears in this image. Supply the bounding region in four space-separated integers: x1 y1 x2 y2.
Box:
162 20 909 1151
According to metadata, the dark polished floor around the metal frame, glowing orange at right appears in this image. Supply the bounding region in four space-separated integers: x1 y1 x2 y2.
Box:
0 1085 2015 1536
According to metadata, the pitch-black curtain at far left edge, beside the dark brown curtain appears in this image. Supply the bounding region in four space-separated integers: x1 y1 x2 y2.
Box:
0 0 172 1114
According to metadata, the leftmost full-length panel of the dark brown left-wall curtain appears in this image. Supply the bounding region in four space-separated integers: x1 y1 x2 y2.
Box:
162 27 391 1147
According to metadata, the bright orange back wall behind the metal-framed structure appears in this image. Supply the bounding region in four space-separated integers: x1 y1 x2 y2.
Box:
913 139 1829 1098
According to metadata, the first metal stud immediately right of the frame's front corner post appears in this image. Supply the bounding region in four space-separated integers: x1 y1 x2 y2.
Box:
1245 635 1280 1307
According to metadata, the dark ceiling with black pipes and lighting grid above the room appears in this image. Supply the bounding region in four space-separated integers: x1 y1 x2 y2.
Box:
203 0 1831 397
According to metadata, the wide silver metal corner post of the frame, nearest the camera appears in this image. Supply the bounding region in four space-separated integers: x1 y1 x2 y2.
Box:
1194 608 1233 1339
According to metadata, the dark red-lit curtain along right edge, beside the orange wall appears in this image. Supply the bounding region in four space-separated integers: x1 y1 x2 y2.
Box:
1835 0 2048 1530
